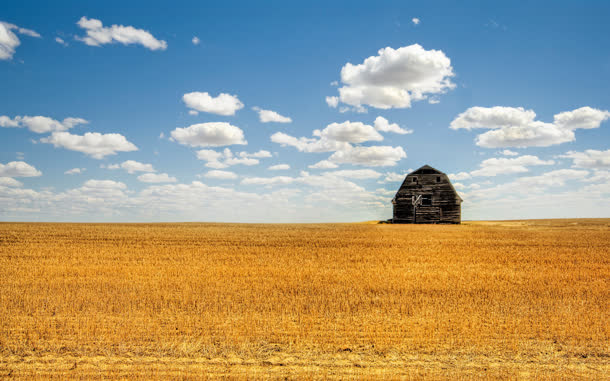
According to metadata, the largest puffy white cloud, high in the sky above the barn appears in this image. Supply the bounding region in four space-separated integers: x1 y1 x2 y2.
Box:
332 44 455 109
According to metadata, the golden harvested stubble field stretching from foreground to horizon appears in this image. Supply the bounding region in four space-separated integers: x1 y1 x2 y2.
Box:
0 219 610 378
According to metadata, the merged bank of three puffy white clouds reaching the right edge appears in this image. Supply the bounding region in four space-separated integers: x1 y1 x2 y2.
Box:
449 106 610 148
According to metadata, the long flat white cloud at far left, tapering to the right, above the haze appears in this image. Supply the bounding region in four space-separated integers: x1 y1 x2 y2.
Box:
40 132 138 159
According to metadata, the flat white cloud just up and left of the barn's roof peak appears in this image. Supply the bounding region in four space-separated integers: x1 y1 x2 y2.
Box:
328 146 407 167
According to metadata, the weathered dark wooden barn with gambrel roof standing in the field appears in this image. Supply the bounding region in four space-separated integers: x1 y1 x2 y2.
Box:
392 165 462 224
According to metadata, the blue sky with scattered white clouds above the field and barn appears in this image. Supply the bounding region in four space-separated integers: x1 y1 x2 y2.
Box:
0 0 610 222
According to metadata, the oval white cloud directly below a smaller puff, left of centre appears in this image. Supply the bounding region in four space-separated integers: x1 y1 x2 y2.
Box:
171 122 248 147
